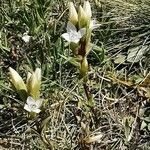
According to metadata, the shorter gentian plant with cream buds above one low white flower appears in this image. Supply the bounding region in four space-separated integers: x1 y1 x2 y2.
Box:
9 67 43 116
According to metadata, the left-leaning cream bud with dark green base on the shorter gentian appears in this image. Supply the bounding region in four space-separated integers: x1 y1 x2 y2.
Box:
9 67 27 100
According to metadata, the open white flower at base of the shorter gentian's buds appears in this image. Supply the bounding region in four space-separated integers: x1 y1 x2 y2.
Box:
24 96 43 113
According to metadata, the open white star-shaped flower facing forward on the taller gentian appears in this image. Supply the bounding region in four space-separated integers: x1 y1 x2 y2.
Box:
62 22 86 43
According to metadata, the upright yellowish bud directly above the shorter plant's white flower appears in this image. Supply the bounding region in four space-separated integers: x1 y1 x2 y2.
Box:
27 68 41 99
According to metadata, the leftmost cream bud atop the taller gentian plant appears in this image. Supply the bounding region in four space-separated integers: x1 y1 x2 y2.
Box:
69 2 78 26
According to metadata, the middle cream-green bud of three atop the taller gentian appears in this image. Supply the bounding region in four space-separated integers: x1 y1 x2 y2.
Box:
78 5 88 29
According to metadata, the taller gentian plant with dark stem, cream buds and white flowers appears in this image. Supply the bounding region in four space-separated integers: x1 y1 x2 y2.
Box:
62 1 100 100
